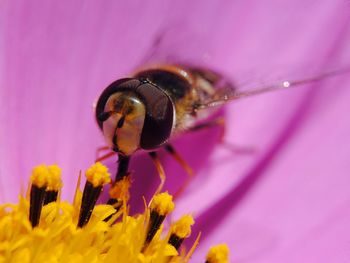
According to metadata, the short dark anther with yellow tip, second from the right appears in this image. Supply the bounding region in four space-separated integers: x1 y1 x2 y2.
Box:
168 215 194 249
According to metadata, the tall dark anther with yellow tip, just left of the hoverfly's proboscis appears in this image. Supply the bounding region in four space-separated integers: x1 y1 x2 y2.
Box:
78 163 111 227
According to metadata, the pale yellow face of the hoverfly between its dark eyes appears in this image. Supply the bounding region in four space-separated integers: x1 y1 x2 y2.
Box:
103 92 145 155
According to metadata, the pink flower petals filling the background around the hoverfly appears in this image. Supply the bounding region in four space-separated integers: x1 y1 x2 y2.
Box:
0 1 350 262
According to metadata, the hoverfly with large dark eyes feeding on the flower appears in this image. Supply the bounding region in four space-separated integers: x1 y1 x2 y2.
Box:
95 64 349 202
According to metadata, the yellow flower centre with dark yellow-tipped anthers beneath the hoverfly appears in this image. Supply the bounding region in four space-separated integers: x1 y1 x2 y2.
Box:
0 164 228 263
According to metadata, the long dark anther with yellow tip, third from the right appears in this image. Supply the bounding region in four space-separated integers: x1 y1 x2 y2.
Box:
142 192 175 251
